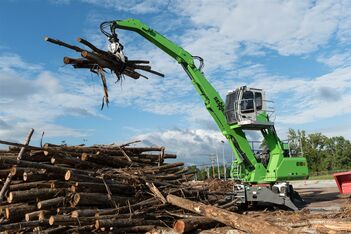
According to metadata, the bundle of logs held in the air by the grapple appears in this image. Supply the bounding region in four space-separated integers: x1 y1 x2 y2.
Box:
45 37 164 107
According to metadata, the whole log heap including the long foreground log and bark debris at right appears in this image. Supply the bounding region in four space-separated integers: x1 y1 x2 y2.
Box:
0 133 351 234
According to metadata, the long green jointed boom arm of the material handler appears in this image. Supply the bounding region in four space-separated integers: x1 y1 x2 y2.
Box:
113 19 265 181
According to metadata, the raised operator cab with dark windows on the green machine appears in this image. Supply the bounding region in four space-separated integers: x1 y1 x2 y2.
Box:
225 86 273 130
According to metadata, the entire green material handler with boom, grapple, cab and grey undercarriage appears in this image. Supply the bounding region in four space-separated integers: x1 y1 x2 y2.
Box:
100 19 308 210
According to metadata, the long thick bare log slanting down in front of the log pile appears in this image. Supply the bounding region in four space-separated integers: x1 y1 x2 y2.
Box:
167 194 289 233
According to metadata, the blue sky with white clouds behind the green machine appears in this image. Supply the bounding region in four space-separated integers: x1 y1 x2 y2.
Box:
0 0 351 164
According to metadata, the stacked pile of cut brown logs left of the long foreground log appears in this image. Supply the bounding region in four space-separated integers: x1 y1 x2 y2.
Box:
0 141 205 233
